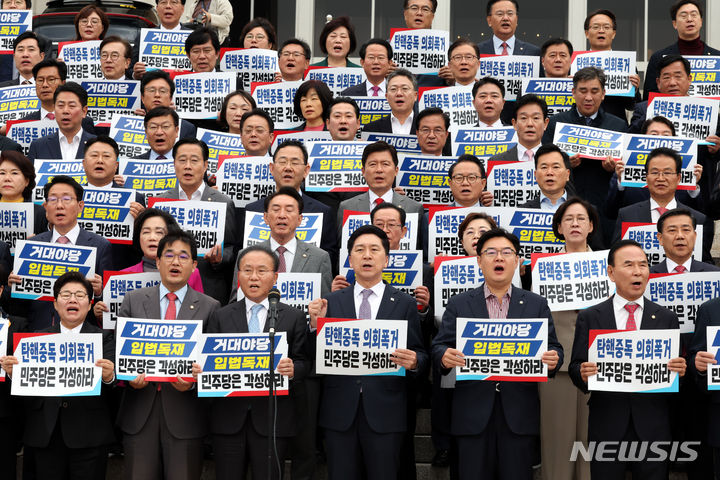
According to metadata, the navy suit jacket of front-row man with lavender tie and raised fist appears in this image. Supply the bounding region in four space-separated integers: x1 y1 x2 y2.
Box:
311 285 428 433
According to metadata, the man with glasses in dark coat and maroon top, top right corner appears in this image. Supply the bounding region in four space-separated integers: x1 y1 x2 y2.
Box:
643 0 720 100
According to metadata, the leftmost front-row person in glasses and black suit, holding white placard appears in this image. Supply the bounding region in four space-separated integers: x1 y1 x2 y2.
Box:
2 272 115 480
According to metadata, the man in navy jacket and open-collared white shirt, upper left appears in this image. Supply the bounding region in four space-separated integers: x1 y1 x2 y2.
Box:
28 83 95 160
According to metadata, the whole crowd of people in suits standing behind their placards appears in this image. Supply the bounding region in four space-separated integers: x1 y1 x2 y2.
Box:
0 0 720 480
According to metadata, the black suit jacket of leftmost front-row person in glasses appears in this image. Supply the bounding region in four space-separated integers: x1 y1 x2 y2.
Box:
24 322 115 448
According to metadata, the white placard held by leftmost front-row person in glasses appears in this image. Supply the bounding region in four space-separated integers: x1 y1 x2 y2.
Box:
11 333 103 397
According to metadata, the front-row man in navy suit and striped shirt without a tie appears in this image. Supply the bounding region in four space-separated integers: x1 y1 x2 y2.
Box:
432 228 563 479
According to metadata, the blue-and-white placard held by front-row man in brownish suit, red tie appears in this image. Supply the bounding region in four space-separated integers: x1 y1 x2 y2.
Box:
115 317 203 382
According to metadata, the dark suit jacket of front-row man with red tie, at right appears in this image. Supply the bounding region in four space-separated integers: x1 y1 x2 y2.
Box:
568 297 679 441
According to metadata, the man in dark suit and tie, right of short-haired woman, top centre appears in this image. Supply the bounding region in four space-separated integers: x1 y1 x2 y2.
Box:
340 38 392 97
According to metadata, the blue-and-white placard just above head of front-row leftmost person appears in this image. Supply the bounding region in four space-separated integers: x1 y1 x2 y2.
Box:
12 240 97 301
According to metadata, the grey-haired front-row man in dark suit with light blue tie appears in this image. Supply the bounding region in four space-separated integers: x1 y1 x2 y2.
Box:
198 245 306 480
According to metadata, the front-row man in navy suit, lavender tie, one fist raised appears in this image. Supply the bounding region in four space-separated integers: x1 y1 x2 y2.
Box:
309 225 428 480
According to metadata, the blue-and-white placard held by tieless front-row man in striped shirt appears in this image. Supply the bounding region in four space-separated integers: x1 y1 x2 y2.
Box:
455 318 548 382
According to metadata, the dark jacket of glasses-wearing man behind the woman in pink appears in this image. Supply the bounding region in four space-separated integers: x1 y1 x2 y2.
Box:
158 185 242 305
